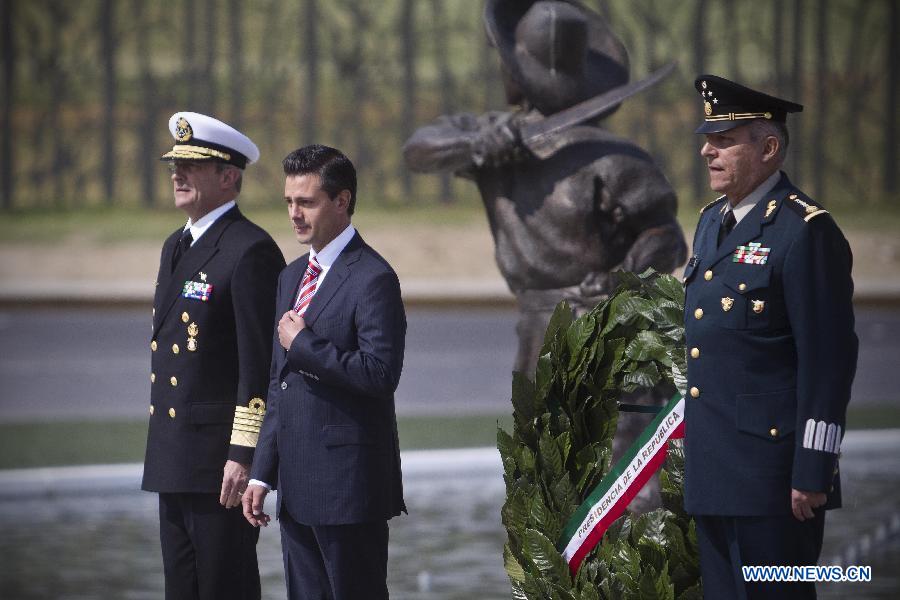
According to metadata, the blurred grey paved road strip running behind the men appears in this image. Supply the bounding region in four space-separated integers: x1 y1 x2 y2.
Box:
0 309 900 422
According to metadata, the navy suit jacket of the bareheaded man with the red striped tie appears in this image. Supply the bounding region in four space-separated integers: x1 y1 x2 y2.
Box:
251 234 406 526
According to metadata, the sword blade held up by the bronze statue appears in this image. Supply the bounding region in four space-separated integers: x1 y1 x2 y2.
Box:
519 62 675 158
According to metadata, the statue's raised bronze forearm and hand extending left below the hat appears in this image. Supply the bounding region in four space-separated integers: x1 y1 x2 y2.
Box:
403 113 519 172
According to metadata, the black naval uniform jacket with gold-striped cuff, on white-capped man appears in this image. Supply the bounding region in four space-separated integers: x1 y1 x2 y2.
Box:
142 207 284 493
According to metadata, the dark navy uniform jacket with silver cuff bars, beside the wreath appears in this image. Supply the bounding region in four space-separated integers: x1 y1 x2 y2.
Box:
684 173 858 515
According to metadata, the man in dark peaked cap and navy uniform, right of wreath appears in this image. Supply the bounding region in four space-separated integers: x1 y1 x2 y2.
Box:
684 75 858 600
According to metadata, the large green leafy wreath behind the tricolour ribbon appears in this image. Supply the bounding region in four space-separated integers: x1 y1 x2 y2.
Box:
497 271 702 600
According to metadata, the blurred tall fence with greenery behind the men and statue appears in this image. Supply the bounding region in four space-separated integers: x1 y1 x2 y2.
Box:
0 0 900 208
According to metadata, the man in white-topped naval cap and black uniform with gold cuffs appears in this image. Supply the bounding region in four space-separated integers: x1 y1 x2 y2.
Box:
141 112 284 600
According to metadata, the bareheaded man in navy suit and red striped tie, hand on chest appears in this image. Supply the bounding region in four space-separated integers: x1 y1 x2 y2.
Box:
243 145 406 600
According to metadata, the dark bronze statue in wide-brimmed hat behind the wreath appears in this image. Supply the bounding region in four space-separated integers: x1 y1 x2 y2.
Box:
403 0 687 510
